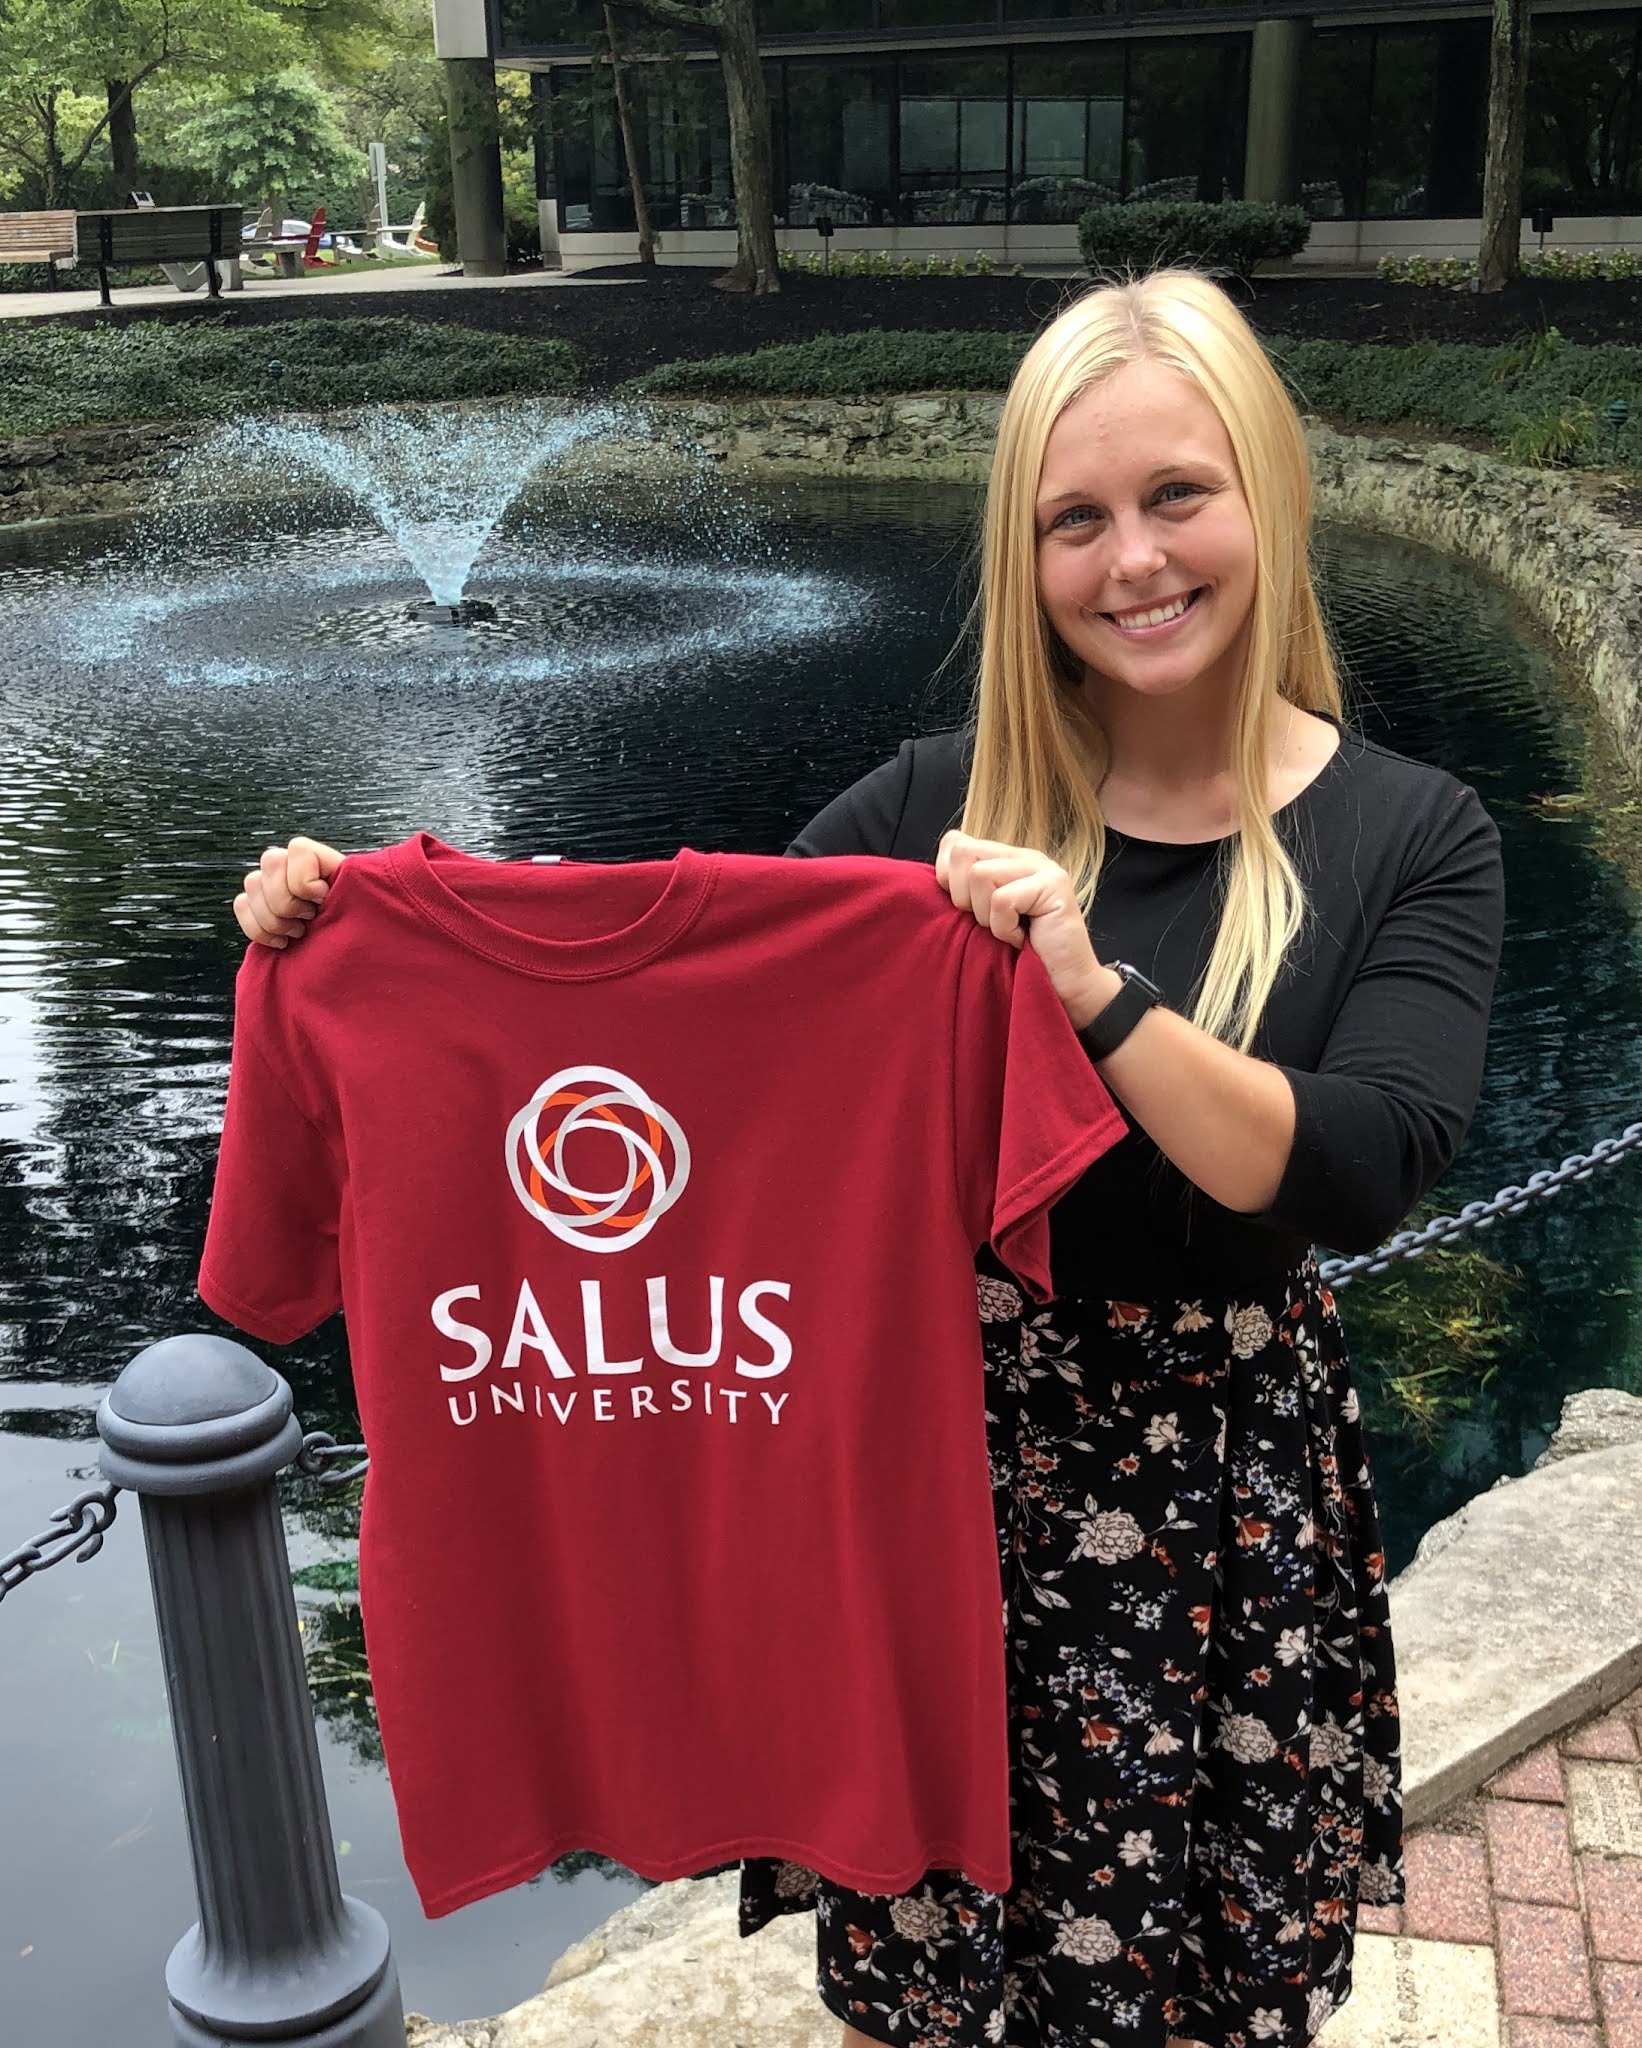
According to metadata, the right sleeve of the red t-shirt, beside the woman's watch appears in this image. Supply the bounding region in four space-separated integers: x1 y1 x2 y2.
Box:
952 926 1128 1303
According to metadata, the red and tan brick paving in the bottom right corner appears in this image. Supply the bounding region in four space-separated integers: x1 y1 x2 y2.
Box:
1319 1692 1642 2048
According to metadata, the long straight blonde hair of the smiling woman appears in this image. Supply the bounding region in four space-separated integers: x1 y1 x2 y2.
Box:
962 270 1341 1051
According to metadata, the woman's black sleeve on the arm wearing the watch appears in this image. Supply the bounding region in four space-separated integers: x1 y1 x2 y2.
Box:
1263 786 1505 1251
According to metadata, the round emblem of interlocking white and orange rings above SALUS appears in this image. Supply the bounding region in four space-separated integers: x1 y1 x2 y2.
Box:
508 1067 690 1251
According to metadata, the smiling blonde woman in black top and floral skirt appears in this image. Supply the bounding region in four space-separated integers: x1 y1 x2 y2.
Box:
235 270 1503 2048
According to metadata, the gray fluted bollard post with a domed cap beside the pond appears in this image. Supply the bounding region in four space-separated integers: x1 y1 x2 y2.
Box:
96 1335 405 2048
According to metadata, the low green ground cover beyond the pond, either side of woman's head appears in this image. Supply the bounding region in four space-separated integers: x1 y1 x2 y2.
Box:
626 328 1642 467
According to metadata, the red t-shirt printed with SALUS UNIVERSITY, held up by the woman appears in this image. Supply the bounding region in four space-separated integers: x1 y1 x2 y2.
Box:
199 834 1124 1915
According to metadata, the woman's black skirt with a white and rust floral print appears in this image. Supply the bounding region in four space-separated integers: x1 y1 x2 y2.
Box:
741 1255 1402 2048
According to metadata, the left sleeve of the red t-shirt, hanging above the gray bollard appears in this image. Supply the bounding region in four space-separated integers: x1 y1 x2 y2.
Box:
199 946 342 1343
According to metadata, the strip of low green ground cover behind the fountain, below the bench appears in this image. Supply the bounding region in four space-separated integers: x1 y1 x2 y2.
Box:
0 317 579 434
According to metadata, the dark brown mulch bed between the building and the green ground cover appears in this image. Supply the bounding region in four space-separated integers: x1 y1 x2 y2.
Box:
15 264 1642 389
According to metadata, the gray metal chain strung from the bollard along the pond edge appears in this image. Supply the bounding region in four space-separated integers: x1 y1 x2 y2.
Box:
0 1122 1642 1564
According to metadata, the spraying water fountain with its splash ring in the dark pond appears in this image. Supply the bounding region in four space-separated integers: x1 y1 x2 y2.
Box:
19 399 850 688
